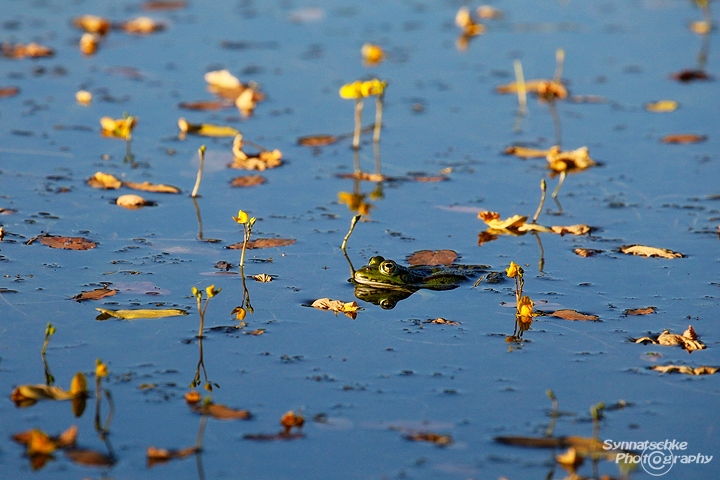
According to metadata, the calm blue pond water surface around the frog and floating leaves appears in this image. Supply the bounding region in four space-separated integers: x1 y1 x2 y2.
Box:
0 0 720 479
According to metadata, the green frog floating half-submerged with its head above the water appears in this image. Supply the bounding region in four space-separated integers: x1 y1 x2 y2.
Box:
352 255 490 292
